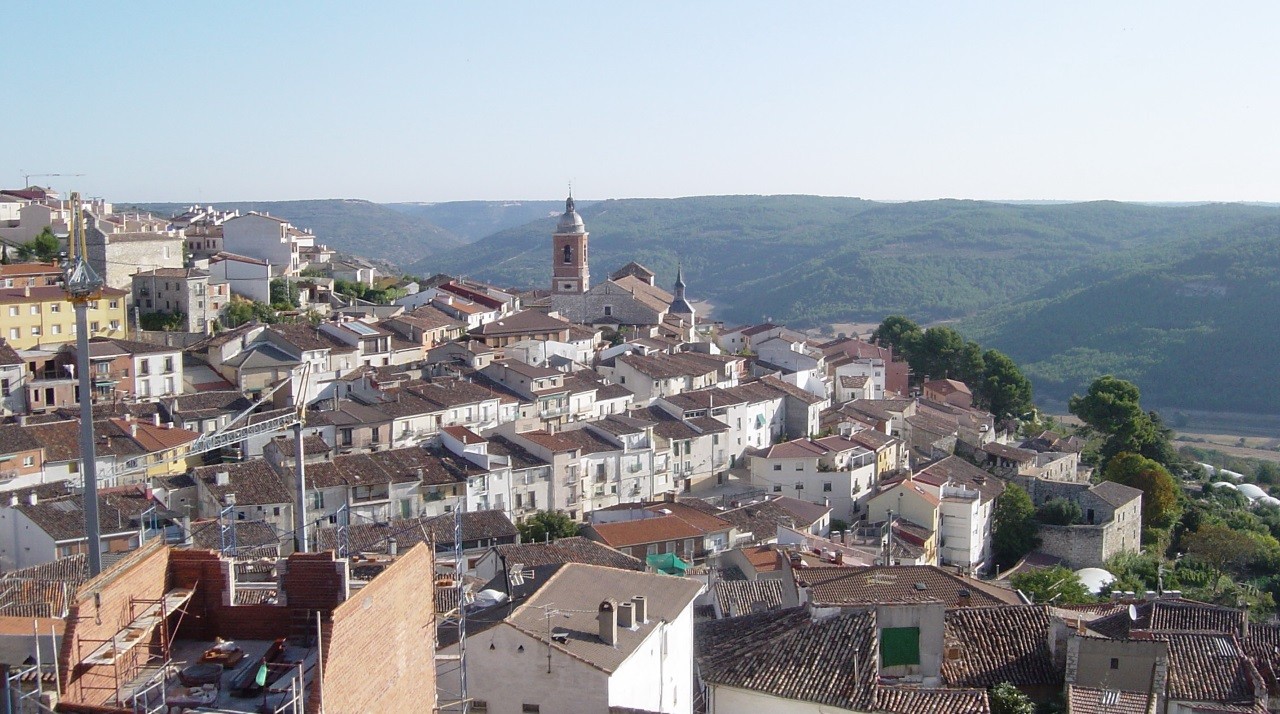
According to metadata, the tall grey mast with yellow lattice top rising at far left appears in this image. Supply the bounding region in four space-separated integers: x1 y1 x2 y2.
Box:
63 192 102 577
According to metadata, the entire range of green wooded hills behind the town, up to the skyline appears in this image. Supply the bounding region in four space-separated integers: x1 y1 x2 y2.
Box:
127 196 1280 413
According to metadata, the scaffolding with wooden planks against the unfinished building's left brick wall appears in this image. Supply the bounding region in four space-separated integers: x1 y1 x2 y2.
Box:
76 587 195 711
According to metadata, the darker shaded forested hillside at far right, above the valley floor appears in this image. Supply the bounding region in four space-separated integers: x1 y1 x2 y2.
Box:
960 216 1280 413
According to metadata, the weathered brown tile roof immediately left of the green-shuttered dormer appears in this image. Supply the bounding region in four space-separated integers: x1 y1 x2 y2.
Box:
694 608 878 711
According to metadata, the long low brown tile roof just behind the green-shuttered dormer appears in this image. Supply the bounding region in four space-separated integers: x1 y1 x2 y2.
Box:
796 566 1019 607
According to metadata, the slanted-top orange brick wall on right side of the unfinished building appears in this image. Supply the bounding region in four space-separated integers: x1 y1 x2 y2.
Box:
306 544 436 713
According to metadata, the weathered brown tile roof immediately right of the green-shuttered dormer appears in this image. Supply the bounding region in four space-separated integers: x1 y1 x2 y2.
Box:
942 605 1062 687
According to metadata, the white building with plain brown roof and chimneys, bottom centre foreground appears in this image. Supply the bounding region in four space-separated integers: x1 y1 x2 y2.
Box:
438 563 703 714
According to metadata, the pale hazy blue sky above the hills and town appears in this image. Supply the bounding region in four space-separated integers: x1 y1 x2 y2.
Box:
0 0 1280 202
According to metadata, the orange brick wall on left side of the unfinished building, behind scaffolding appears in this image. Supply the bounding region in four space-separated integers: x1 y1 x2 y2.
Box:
58 539 169 704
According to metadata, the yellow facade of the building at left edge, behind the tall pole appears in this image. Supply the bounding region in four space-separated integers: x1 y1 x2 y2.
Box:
0 285 129 349
